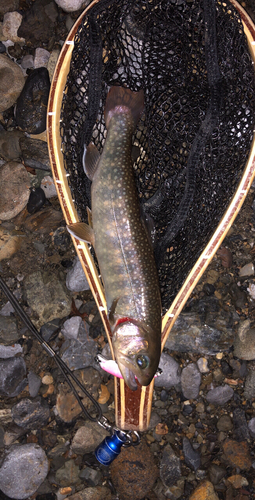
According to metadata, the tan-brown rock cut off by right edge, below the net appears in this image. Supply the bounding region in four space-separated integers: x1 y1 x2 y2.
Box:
234 319 255 361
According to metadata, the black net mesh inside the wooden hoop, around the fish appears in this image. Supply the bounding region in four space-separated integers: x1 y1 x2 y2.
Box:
61 0 255 311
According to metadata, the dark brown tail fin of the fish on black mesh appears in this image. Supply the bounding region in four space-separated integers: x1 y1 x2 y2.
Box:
104 86 144 127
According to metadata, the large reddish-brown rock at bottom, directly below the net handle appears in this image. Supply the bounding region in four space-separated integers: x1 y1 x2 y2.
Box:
110 441 158 500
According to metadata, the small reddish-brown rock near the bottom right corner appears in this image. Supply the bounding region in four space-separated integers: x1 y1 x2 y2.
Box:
223 439 252 470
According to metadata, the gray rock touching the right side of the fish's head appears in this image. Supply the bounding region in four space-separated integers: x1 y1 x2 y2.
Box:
155 352 181 390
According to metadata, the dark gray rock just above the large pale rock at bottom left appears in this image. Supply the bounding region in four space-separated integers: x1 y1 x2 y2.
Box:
12 398 50 429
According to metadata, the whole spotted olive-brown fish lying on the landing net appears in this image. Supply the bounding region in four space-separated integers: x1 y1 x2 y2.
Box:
67 85 161 391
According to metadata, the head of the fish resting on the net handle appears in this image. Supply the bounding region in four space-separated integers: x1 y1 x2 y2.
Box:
112 320 161 391
